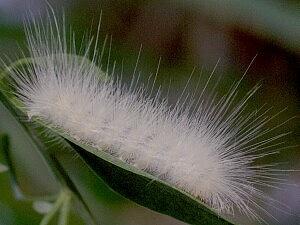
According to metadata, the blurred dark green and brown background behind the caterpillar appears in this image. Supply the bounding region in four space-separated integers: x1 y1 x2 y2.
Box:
0 0 300 225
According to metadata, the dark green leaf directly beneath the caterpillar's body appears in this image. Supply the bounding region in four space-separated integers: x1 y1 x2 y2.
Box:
61 134 231 225
